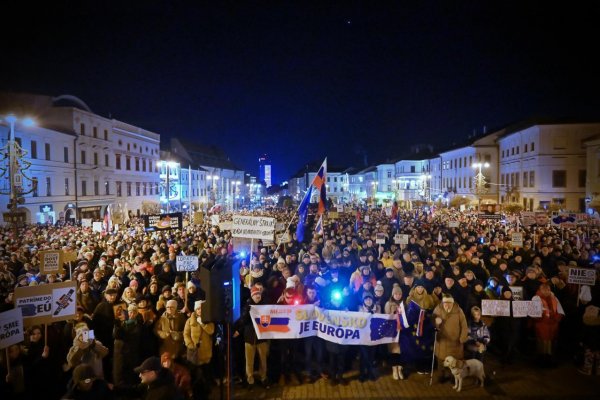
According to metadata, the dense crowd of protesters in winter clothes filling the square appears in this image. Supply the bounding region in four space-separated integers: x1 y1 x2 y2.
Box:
0 208 600 399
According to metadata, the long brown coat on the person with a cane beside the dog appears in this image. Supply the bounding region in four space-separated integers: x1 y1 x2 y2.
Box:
432 303 469 360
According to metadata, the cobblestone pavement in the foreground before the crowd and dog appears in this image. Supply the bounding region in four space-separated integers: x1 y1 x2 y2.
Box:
225 357 600 400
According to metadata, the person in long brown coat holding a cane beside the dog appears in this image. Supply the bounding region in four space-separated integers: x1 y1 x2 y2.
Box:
433 294 469 383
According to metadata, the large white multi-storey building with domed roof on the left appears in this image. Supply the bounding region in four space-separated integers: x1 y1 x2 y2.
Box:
0 93 160 222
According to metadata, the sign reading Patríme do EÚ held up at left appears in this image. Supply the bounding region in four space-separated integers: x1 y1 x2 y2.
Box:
15 281 77 326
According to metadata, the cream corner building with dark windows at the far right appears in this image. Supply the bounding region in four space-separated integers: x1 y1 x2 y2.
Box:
498 123 600 211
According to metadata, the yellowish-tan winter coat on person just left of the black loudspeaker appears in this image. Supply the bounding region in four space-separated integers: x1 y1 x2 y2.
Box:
183 314 215 365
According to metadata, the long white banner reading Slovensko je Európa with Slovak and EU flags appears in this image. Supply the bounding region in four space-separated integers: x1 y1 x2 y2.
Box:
250 305 399 346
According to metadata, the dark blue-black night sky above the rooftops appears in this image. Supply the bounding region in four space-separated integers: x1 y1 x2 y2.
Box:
0 0 600 182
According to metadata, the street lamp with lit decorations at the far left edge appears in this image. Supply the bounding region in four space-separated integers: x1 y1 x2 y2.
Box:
0 114 38 230
